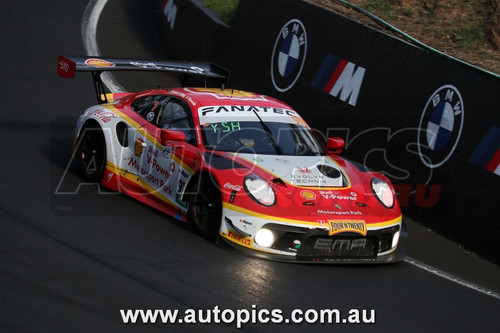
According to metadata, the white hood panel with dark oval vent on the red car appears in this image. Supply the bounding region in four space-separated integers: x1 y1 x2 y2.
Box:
234 154 346 187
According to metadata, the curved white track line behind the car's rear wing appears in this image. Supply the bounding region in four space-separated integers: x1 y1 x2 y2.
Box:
82 0 125 93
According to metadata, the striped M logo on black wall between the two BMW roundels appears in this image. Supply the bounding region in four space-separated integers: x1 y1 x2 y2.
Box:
311 53 366 106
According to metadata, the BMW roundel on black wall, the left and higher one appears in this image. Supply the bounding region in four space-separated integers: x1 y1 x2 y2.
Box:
271 19 307 92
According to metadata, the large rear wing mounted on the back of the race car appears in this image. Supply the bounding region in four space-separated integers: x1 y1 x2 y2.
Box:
57 55 229 104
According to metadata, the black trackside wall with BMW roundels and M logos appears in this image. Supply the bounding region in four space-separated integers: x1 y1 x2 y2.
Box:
160 0 500 263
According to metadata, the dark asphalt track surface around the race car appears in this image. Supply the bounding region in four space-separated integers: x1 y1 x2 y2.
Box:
0 0 500 332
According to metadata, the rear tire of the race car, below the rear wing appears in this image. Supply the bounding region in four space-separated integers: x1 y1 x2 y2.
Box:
75 125 106 182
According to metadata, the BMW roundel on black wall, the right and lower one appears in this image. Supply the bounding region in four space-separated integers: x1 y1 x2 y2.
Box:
418 85 464 168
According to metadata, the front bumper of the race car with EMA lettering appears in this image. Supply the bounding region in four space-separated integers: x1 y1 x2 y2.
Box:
218 205 405 264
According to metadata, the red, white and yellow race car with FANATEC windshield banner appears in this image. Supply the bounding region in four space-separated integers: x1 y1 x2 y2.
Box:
58 56 404 263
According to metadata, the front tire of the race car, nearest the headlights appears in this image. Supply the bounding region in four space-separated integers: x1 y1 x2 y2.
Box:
188 177 222 240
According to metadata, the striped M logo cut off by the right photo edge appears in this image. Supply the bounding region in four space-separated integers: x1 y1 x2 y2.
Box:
469 126 500 176
